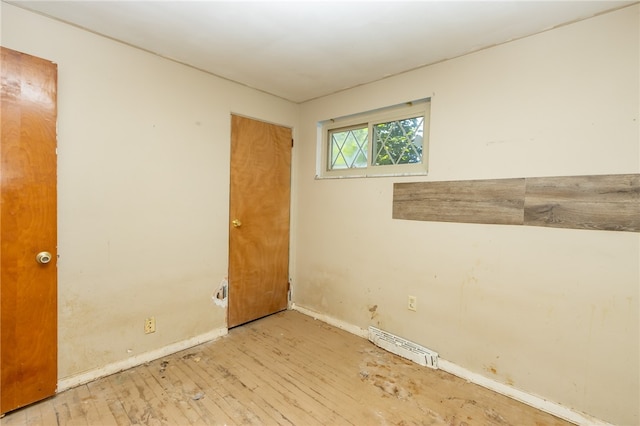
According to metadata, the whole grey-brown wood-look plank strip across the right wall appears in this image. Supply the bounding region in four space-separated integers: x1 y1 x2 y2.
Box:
393 174 640 232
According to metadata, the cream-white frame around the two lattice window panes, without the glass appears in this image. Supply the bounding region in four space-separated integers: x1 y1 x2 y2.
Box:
316 98 431 179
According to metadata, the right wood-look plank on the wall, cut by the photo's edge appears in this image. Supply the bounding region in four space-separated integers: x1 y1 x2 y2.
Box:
524 175 640 232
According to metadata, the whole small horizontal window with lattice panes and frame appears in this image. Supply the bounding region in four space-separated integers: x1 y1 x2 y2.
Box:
318 99 430 178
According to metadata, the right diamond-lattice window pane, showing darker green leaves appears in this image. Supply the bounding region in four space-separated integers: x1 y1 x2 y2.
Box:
373 116 424 166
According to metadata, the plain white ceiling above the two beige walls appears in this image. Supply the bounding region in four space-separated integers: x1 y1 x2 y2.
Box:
9 0 635 102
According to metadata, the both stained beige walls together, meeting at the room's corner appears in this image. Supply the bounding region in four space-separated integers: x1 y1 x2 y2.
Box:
0 3 640 424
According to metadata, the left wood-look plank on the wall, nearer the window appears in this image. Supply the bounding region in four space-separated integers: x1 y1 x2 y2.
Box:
393 179 525 225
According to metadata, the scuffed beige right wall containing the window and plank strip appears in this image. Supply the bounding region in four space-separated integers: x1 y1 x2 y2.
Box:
293 5 640 424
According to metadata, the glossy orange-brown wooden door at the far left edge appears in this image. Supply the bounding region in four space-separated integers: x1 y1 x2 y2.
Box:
0 48 58 413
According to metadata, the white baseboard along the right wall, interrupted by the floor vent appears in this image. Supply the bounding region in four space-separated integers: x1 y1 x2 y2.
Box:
291 303 613 426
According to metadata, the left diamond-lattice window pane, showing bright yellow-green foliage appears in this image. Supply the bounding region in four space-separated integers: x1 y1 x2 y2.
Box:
329 127 369 170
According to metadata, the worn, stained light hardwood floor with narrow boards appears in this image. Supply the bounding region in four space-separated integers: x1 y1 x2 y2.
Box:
2 311 570 426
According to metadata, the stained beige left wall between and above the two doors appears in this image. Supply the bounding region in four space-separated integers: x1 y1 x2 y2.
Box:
1 3 298 379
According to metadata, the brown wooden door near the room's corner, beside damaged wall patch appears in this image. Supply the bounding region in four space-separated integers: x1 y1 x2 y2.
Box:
228 115 292 327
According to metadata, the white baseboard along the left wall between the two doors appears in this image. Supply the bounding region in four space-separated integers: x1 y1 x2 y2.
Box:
57 328 228 392
